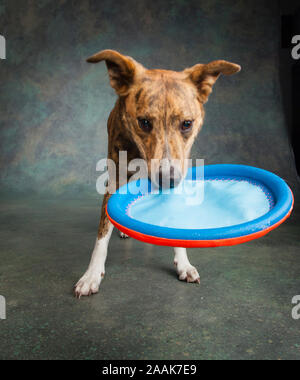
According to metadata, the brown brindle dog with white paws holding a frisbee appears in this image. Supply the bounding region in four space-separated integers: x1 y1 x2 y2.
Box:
75 50 241 298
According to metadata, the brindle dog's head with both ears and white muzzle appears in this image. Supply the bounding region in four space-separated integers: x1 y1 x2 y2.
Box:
87 50 241 188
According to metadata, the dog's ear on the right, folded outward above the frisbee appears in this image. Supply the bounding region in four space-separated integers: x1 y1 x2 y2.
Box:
184 60 241 103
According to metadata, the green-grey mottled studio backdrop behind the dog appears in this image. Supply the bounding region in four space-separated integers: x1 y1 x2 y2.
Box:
0 0 296 197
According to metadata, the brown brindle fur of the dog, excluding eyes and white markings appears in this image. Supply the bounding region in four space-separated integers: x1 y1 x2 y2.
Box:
87 50 240 238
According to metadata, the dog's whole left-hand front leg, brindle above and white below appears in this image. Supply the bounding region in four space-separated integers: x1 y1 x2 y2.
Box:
75 193 113 298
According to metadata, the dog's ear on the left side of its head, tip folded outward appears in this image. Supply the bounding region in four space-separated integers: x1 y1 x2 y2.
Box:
87 50 141 96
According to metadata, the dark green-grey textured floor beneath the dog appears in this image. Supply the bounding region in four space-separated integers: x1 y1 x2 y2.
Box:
0 200 300 359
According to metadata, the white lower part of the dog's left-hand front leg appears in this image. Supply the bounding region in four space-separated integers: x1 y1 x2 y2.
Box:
75 224 113 298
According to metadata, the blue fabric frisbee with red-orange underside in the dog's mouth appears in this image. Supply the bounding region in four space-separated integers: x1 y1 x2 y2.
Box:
106 164 294 248
